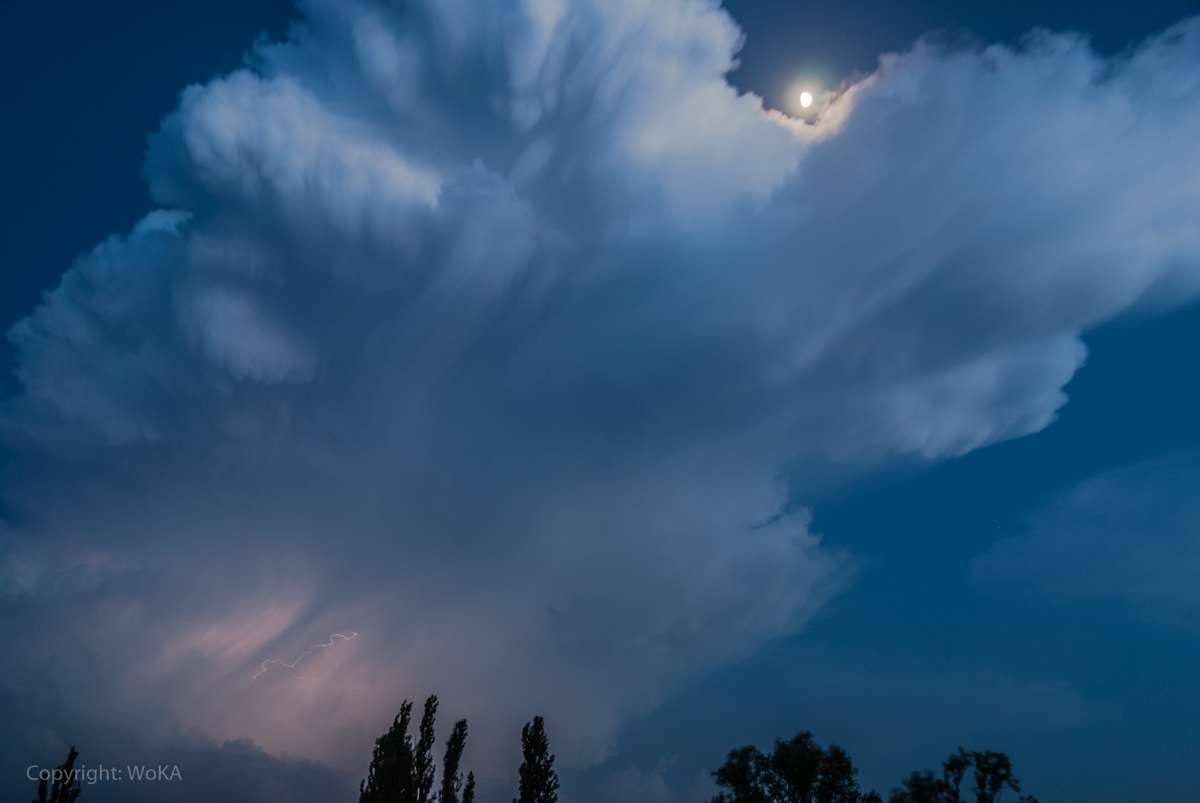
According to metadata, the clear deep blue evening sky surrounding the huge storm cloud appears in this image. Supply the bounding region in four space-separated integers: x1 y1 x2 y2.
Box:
0 0 1200 803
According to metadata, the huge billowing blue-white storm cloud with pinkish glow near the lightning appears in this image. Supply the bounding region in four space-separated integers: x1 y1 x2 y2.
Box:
2 0 1200 796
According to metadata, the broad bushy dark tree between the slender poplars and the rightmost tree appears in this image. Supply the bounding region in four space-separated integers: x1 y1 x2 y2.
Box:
710 731 882 803
